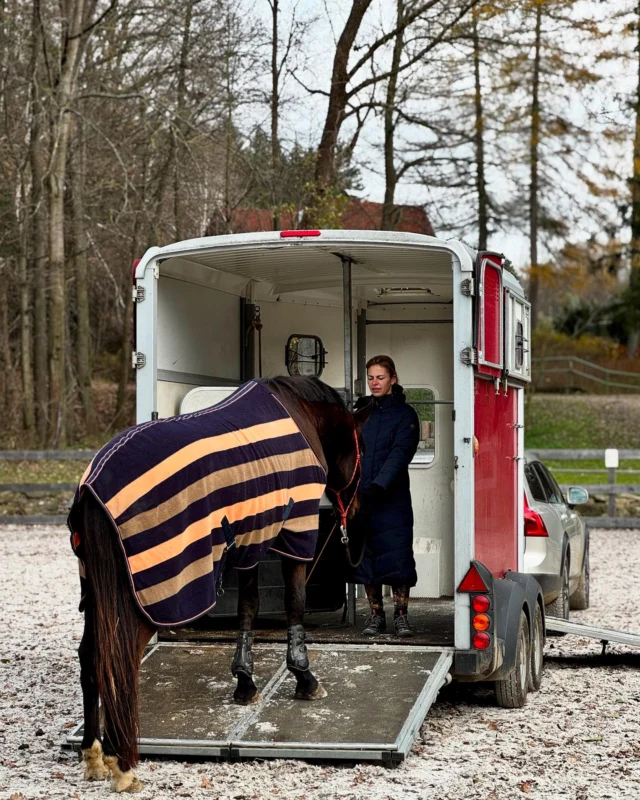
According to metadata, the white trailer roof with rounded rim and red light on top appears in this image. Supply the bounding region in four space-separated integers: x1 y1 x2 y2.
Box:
141 230 524 302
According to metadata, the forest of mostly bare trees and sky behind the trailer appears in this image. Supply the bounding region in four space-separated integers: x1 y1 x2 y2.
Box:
0 0 640 448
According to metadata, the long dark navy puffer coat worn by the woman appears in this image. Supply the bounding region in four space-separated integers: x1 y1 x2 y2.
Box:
352 383 420 586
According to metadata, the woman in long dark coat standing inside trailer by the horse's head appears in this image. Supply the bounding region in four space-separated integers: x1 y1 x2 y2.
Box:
353 355 420 637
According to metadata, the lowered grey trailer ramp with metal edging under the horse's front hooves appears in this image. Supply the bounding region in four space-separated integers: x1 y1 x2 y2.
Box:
65 643 453 765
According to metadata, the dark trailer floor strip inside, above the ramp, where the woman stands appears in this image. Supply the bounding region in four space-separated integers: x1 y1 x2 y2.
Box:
158 597 454 647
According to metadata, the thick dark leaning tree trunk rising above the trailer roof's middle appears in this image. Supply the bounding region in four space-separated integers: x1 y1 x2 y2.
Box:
315 0 372 193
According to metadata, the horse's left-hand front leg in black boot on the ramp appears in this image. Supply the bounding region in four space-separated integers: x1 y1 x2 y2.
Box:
231 564 262 705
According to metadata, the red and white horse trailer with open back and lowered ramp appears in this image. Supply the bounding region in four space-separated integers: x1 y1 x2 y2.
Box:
69 230 545 763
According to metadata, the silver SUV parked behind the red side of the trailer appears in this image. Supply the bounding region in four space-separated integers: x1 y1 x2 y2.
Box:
524 461 589 619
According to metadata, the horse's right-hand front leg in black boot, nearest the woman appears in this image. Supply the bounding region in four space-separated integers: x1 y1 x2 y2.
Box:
282 558 327 700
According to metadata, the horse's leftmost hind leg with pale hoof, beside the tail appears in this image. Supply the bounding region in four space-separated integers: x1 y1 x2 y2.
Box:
78 599 109 781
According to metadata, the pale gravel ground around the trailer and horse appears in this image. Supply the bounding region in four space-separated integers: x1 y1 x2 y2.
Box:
0 527 640 800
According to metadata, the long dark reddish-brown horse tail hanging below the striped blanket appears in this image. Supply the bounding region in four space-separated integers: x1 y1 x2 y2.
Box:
81 491 142 771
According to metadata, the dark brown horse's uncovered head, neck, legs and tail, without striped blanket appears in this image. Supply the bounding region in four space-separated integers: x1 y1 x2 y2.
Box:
73 377 366 792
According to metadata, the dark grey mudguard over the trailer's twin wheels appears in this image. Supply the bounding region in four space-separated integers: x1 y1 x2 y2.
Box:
487 571 544 681
